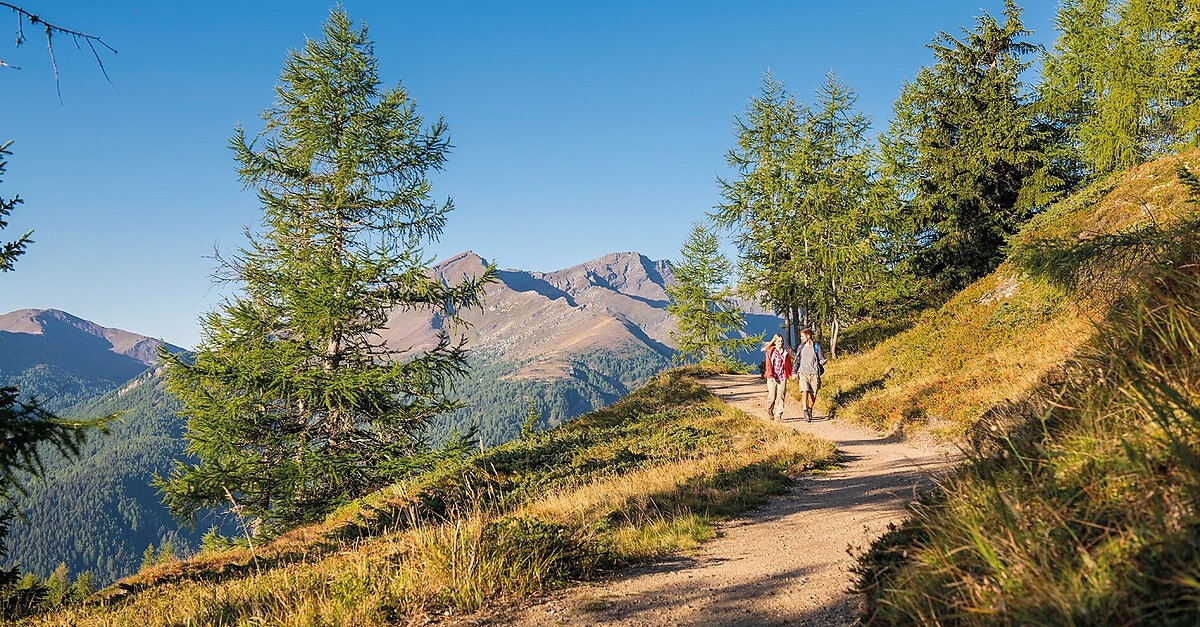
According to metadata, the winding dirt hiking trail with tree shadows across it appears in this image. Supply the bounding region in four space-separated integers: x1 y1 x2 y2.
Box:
473 375 953 626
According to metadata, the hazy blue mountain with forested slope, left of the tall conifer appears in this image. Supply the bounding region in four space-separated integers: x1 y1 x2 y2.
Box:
0 309 205 583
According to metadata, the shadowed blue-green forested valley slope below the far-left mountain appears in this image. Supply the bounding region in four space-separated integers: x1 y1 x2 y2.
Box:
7 372 234 585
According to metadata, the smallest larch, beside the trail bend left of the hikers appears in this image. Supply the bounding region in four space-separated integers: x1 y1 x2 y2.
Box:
667 222 762 366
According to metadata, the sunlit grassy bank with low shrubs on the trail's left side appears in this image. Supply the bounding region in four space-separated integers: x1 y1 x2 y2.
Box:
30 369 834 625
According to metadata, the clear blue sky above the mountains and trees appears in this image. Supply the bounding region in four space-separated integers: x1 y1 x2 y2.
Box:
0 0 1055 346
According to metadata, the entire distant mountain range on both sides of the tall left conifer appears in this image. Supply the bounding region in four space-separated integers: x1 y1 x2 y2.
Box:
0 251 780 583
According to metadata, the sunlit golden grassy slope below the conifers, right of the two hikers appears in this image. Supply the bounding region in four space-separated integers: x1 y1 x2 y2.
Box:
822 153 1200 437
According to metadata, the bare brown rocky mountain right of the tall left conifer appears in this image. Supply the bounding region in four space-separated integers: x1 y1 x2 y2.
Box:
396 251 781 444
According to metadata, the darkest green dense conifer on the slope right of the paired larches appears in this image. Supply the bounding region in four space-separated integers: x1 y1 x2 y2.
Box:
882 0 1067 291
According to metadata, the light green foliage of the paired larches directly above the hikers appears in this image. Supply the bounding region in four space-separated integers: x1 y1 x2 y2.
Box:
712 73 896 351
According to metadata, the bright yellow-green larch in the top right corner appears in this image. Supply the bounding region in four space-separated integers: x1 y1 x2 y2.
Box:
1039 0 1200 175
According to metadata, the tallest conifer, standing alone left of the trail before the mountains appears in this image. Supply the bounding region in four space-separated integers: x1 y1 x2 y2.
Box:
157 8 491 530
